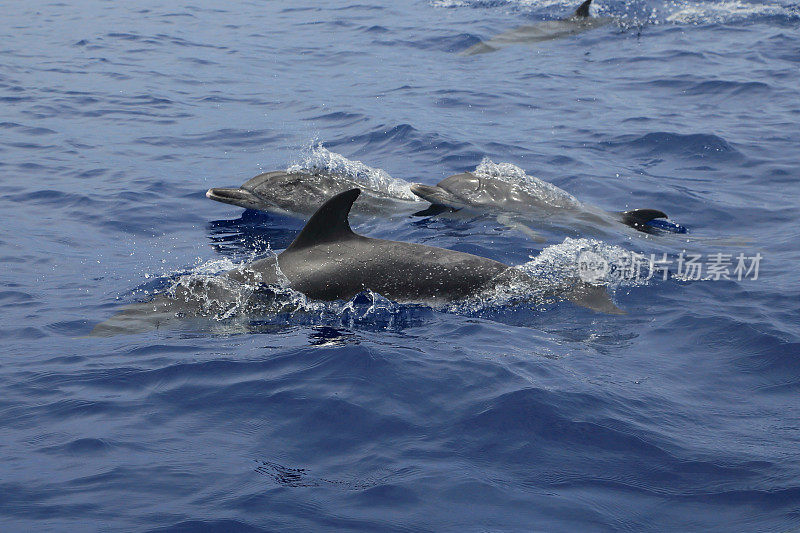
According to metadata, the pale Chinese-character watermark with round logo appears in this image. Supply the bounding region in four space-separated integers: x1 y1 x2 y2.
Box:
578 250 763 283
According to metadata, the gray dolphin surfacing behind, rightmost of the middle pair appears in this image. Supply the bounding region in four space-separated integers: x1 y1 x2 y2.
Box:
411 172 667 240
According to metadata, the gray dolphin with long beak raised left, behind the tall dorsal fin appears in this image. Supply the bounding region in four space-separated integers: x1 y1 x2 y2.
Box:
206 171 419 217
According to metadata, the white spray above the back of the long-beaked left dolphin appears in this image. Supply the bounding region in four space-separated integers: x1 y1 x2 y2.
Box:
286 141 418 201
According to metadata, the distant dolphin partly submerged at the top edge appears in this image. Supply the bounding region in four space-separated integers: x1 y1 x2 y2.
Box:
461 0 614 56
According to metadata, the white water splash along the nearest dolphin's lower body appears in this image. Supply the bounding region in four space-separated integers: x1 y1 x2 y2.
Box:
126 238 649 326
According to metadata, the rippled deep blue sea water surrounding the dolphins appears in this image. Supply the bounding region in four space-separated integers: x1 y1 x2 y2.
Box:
0 0 800 532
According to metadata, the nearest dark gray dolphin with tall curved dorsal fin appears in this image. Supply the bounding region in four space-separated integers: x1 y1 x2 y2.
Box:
91 189 622 336
